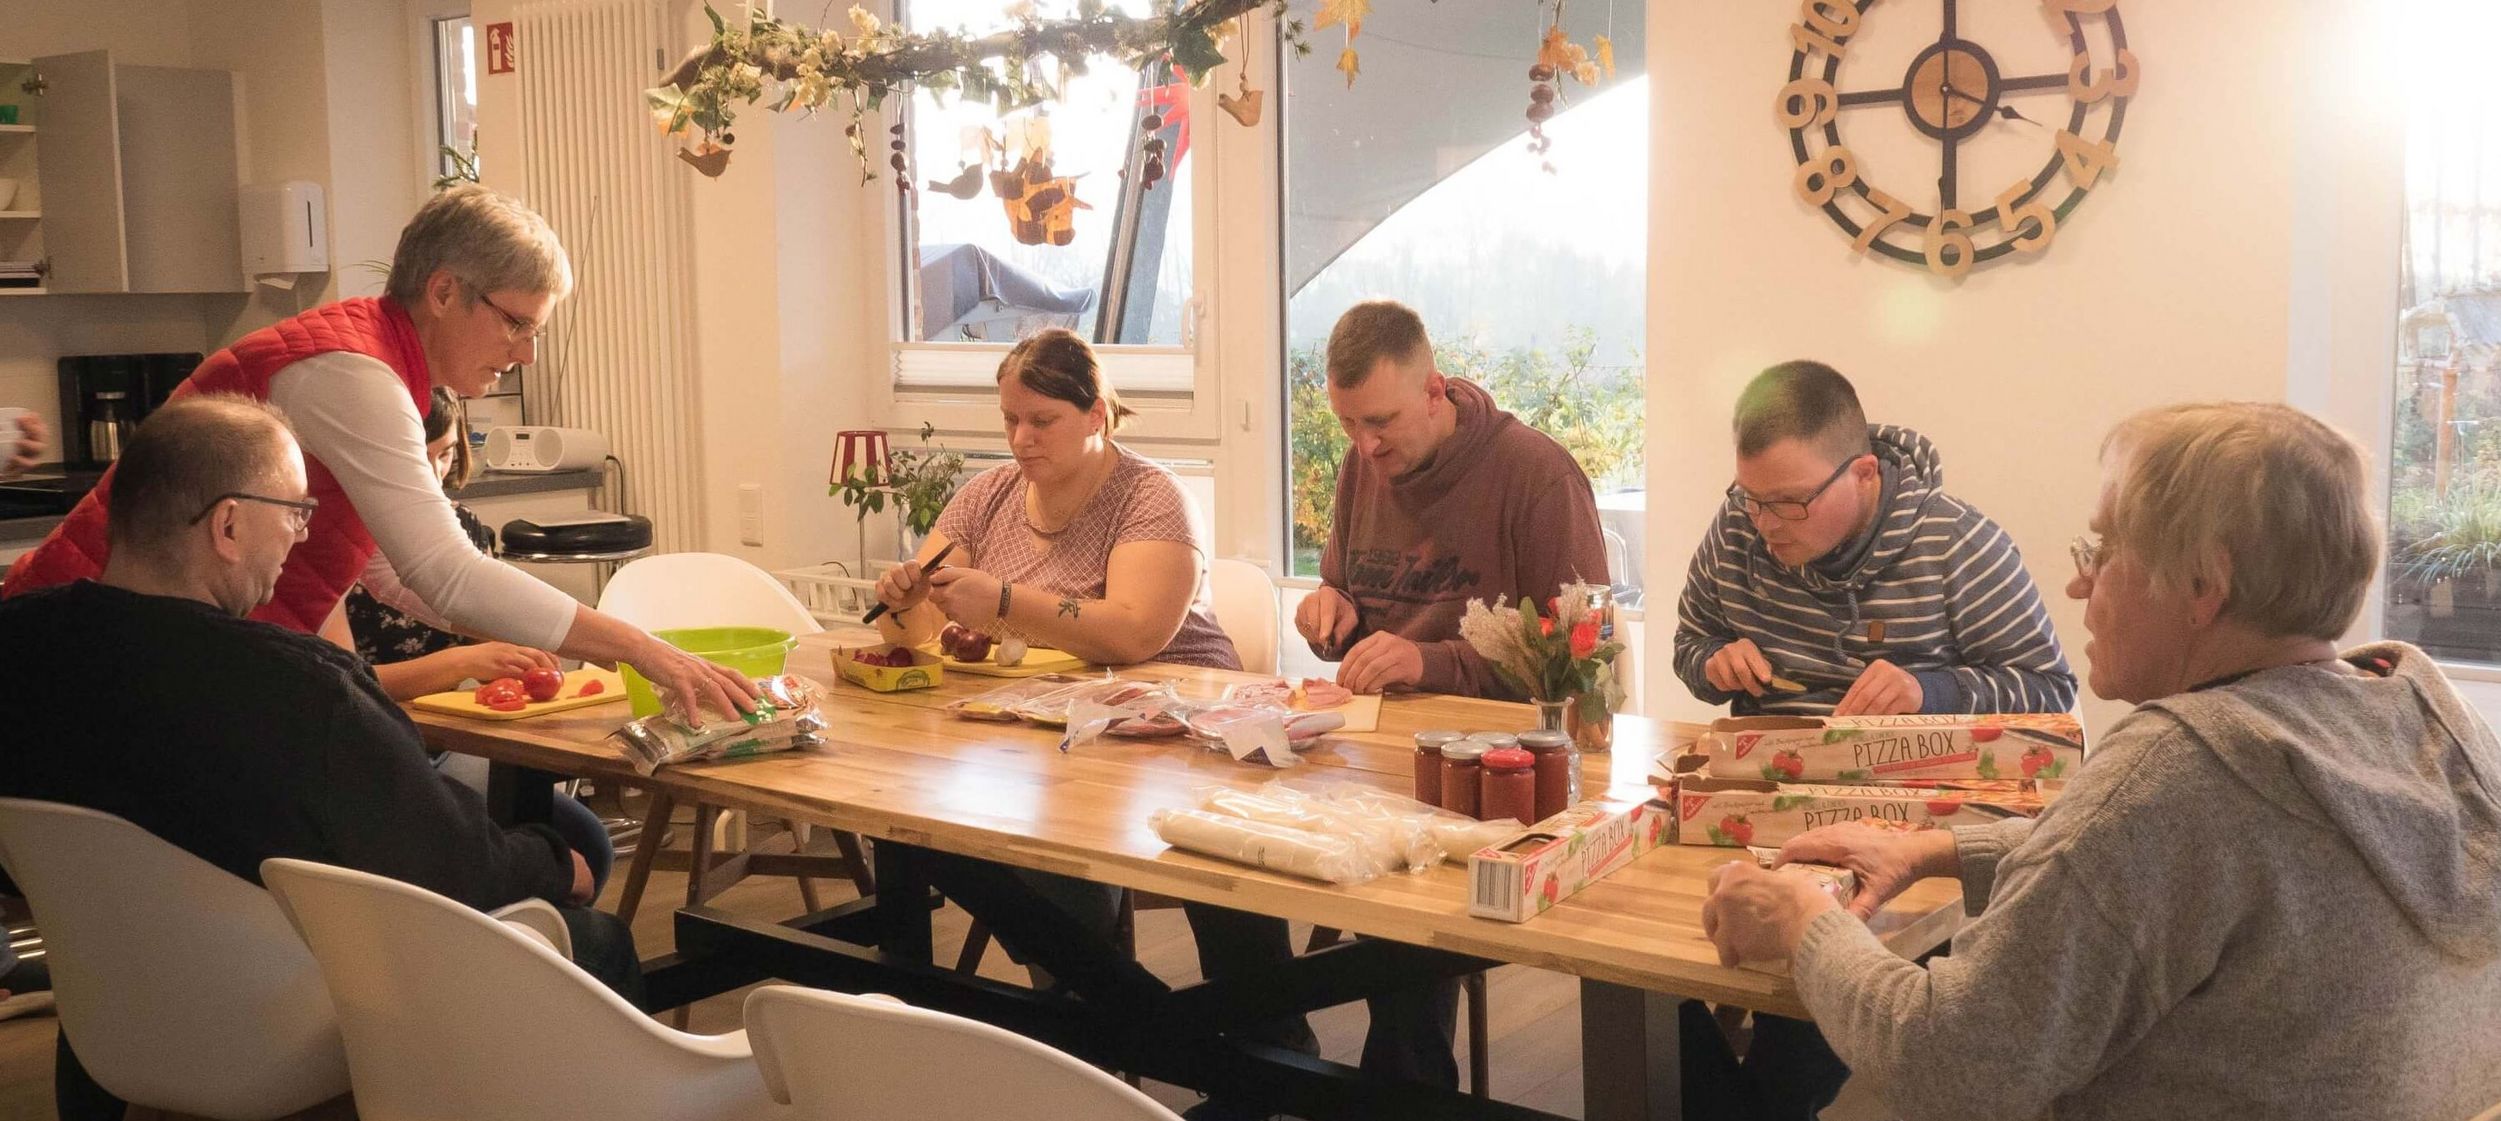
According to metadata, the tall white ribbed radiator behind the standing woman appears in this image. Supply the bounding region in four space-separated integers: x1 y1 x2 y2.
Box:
513 0 703 553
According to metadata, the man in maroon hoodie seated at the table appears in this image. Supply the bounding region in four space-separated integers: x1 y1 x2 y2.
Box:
1293 300 1608 701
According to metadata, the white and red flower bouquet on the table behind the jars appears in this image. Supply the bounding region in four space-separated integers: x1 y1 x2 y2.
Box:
1458 583 1623 751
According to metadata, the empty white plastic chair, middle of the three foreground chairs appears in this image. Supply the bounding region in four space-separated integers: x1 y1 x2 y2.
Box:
260 861 783 1121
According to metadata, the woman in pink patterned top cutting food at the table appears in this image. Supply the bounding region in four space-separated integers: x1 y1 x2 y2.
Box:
878 330 1240 671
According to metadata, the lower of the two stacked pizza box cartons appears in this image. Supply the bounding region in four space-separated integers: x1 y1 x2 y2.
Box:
1673 773 2041 848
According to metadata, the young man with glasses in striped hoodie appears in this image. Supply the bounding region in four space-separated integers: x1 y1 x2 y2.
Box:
1676 363 2076 1121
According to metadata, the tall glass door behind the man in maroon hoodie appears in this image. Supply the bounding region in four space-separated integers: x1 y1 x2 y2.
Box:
1283 0 1648 603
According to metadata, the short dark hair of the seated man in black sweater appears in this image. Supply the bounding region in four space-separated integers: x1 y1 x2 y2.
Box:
105 393 293 555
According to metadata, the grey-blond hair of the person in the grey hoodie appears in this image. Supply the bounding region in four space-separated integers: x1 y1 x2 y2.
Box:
2101 400 2381 641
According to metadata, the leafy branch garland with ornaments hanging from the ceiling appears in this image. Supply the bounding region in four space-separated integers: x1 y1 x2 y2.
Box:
643 0 1613 181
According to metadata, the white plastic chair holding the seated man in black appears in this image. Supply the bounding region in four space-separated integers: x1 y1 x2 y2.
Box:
0 798 348 1121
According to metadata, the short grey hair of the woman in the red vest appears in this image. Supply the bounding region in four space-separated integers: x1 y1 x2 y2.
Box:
383 183 573 308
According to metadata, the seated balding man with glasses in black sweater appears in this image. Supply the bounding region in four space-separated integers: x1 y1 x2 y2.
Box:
0 395 640 1118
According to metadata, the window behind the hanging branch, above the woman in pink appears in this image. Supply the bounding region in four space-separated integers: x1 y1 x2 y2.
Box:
900 0 1193 347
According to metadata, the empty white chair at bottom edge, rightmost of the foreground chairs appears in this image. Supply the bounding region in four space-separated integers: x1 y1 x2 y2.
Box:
748 986 1175 1121
